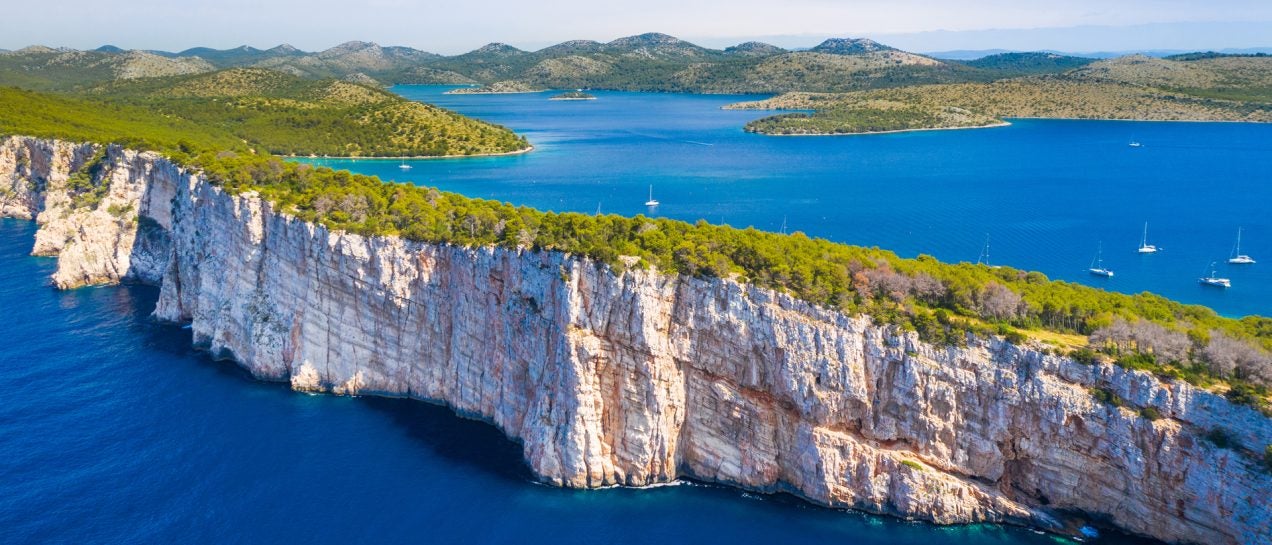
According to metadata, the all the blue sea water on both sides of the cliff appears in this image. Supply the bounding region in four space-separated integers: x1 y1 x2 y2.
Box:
0 87 1256 545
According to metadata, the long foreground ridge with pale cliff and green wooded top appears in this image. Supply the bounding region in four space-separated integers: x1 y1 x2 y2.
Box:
0 77 1272 544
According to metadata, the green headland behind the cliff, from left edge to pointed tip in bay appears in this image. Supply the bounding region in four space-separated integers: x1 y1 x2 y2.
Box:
0 69 528 157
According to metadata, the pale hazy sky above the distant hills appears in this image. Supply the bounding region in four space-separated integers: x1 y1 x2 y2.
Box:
7 0 1272 53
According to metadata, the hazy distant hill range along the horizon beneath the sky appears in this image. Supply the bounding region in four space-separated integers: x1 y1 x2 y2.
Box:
0 33 1261 93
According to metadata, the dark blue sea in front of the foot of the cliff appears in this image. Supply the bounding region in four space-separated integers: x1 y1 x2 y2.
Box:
0 219 1165 545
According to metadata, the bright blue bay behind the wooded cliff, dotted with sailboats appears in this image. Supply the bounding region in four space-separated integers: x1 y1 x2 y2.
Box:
307 85 1272 316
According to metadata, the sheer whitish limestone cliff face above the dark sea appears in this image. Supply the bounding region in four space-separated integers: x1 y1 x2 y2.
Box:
0 138 1272 544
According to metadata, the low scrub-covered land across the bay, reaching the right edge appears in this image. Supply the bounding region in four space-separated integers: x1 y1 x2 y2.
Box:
729 56 1272 135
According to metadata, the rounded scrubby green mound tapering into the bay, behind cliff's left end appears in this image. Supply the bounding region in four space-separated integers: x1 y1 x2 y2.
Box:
89 69 528 157
